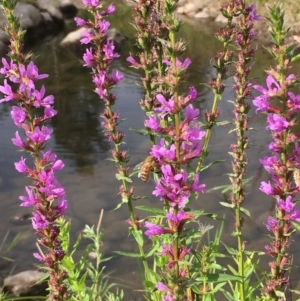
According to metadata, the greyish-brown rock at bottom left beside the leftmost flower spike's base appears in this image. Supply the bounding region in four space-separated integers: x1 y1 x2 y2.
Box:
3 270 47 296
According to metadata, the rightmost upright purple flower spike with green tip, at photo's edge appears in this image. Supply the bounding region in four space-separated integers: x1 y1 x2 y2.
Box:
253 5 300 300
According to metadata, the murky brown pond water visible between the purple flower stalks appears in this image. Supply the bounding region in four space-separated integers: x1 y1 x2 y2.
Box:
0 1 300 300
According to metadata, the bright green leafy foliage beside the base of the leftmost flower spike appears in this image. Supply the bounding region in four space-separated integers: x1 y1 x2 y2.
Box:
59 212 124 301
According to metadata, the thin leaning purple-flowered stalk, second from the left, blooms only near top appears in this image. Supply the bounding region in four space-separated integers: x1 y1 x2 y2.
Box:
75 0 159 300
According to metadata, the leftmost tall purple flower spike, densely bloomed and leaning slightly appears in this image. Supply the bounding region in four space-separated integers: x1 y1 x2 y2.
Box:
0 0 68 300
